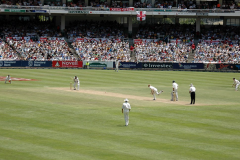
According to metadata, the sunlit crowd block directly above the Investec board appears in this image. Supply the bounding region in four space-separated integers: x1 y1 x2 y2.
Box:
134 42 192 63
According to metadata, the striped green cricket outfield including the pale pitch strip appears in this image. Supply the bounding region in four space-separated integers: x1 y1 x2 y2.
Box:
0 69 240 160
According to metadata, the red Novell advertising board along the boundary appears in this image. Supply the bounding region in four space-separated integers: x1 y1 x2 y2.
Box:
52 61 83 68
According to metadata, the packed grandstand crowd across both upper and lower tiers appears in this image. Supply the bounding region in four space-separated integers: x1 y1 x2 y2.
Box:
0 0 240 63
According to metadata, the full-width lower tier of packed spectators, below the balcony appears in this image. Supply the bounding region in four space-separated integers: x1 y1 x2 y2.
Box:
0 18 240 63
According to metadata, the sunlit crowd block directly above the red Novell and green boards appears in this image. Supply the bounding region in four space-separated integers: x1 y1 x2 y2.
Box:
72 40 131 61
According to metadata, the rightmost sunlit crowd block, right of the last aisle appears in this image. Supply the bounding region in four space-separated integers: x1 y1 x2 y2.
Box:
194 43 240 63
